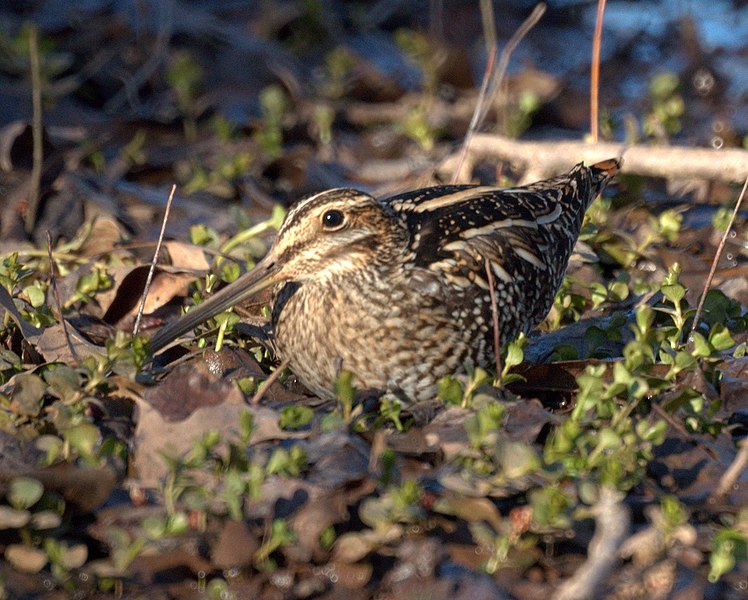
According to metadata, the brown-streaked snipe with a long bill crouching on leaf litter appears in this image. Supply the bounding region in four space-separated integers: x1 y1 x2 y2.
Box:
150 158 622 406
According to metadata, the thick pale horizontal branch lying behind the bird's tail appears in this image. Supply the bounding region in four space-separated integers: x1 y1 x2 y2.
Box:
440 133 748 183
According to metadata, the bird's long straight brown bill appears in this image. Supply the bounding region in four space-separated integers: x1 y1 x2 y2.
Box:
151 252 280 354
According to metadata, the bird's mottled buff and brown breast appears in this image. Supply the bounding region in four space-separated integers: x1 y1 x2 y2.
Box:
273 274 469 398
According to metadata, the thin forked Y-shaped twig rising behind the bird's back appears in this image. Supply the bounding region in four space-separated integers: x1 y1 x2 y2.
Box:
452 3 545 183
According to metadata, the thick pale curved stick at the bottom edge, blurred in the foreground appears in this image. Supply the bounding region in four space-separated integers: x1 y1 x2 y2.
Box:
554 487 630 600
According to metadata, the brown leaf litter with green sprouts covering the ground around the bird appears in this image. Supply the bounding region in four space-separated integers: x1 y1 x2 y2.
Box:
0 1 748 598
